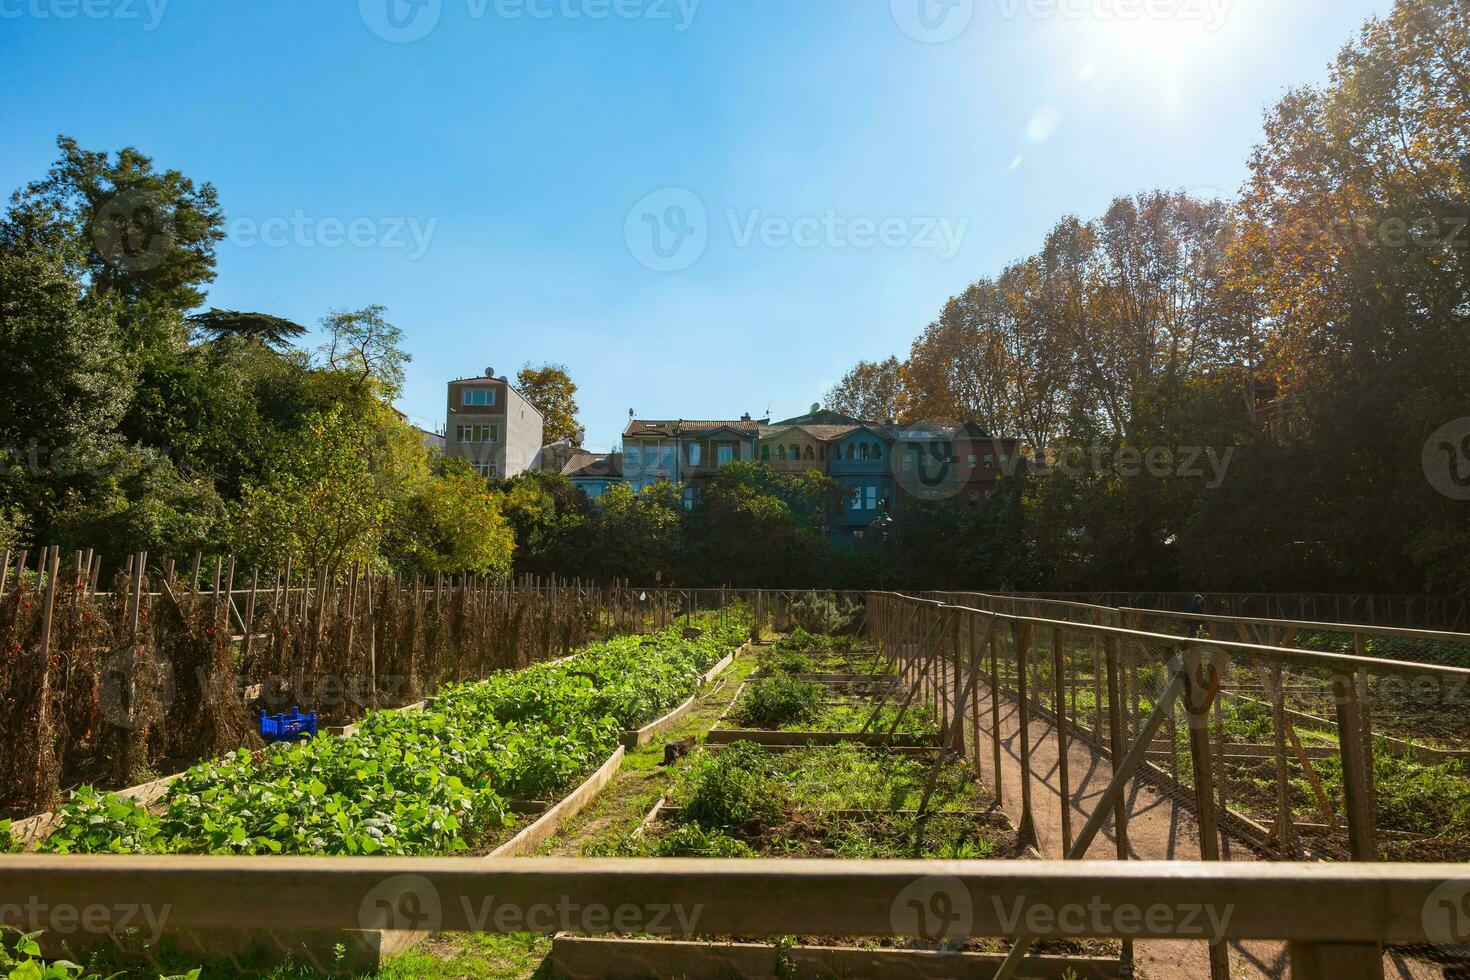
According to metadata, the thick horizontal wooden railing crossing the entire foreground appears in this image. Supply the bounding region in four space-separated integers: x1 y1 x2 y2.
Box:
0 855 1470 980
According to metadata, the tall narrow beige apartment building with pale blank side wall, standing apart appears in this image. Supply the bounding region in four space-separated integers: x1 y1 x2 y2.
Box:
444 370 545 479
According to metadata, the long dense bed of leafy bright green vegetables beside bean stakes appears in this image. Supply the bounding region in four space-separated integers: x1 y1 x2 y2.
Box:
40 617 748 855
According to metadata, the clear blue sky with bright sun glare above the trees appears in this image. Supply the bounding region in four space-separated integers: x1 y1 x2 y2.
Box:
0 0 1389 448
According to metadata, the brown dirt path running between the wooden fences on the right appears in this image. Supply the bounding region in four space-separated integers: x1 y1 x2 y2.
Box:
976 675 1441 980
